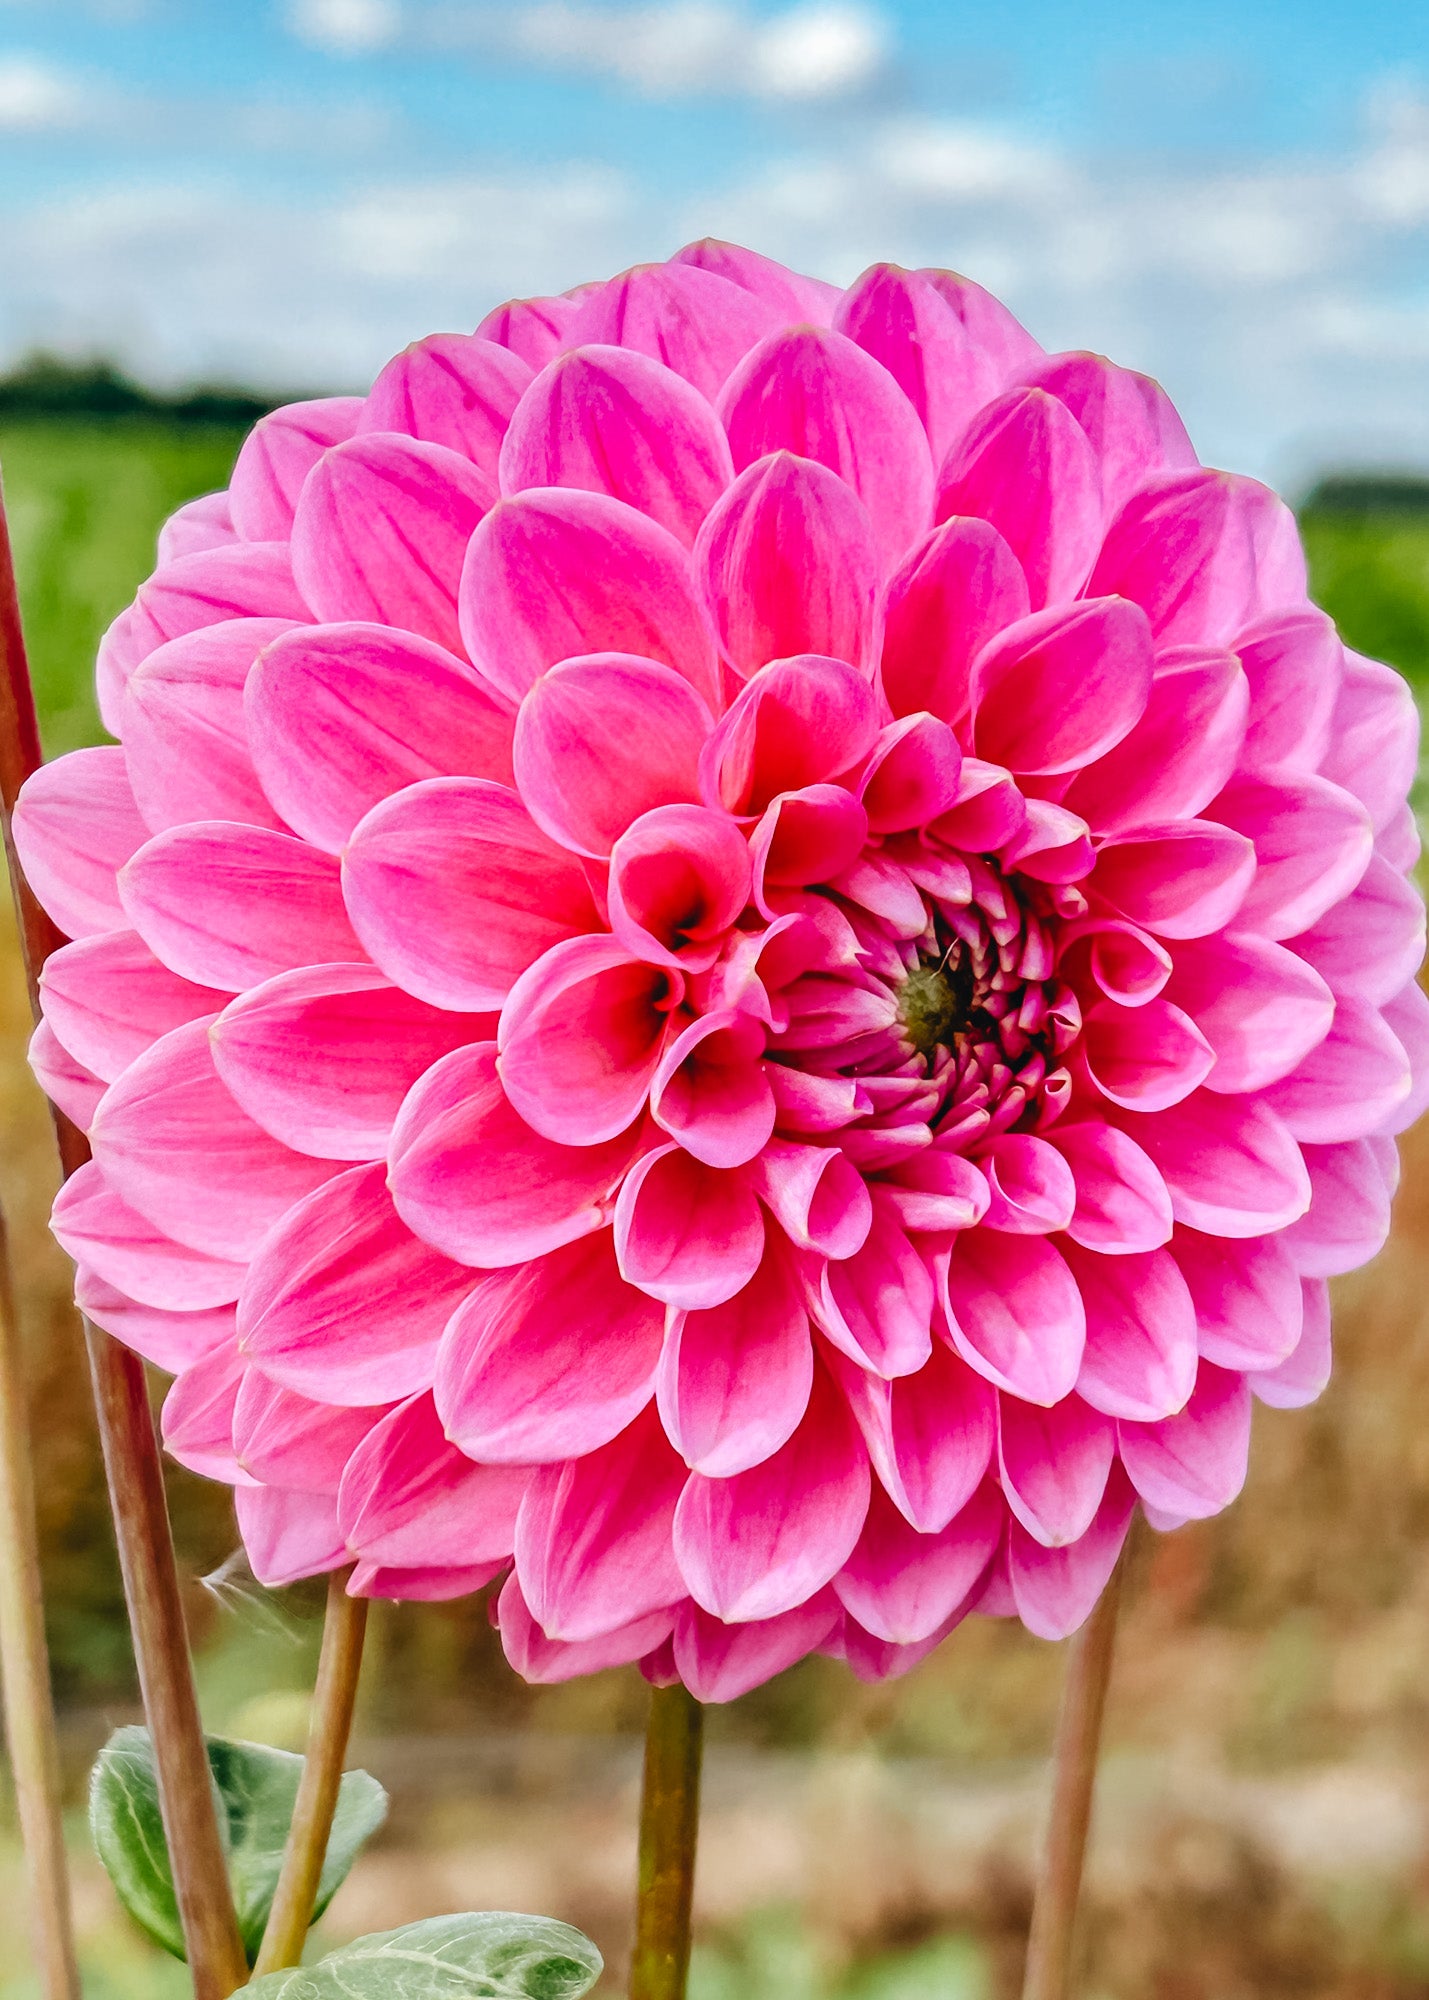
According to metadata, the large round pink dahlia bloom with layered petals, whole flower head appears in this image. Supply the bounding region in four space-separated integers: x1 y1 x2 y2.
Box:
16 242 1429 1700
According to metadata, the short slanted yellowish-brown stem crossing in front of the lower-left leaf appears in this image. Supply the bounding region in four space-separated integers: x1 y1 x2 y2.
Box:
254 1568 366 1976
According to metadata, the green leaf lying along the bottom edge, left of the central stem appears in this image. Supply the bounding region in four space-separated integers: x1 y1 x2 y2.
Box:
244 1910 604 2000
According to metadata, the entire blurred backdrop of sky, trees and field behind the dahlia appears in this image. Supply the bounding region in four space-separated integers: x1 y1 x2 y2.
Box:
0 0 1429 2000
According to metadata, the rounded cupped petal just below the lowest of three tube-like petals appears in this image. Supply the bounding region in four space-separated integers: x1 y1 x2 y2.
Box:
614 1146 765 1310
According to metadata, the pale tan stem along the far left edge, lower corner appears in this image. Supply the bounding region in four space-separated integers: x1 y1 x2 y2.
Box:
0 1214 80 2000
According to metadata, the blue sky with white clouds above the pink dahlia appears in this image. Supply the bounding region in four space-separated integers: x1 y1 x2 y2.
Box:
0 0 1429 484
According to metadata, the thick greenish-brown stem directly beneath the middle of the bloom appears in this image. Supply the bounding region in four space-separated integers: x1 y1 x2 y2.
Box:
630 1682 704 2000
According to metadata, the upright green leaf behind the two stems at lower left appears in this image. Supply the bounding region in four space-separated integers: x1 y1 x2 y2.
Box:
90 1728 386 1962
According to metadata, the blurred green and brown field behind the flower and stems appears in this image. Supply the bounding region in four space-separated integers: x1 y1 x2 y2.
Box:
0 420 1429 2000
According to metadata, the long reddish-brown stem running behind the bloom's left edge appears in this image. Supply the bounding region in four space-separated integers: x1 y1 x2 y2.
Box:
0 488 248 2000
